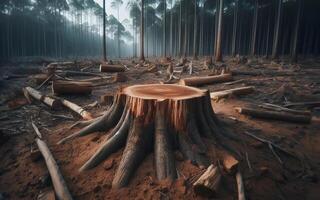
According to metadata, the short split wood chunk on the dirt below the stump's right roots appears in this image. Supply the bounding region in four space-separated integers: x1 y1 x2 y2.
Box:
193 165 221 197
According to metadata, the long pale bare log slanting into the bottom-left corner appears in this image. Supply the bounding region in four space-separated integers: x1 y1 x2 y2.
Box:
36 138 72 200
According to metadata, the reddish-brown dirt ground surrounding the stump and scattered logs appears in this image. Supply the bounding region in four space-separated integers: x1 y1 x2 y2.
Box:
0 59 320 200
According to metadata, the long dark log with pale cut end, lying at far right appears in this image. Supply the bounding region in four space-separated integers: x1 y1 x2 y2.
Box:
235 107 311 123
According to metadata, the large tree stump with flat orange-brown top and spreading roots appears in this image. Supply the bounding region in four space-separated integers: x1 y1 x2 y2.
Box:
59 84 238 188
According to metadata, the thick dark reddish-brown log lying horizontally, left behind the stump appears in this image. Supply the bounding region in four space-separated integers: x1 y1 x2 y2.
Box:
52 81 92 94
